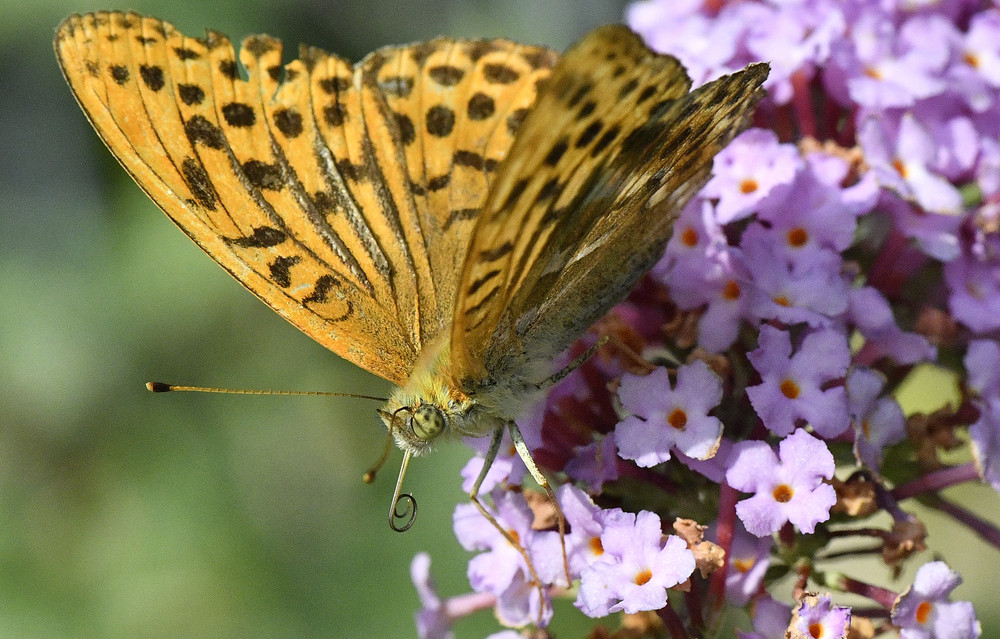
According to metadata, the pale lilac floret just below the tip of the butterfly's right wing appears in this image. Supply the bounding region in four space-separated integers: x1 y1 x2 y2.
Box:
701 129 803 224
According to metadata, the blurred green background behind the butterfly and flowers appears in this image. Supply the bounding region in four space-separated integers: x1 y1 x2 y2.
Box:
0 0 1000 639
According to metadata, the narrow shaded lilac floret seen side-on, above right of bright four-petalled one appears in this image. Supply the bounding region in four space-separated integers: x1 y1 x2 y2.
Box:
847 367 906 473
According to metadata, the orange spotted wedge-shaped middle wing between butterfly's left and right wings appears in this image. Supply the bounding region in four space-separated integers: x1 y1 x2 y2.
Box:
358 38 558 341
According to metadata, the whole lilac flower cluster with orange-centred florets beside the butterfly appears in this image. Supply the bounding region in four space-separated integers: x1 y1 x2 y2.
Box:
415 0 1000 639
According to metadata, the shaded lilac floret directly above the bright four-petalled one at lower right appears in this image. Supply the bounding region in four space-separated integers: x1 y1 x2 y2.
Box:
747 326 850 437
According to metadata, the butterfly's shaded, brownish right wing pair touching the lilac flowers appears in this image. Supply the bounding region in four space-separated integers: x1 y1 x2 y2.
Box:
451 25 767 384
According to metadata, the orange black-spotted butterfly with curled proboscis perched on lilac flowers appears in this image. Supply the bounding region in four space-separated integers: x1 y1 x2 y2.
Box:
55 6 768 592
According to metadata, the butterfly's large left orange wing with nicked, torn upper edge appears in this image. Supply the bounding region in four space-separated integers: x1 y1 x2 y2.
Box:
55 12 556 383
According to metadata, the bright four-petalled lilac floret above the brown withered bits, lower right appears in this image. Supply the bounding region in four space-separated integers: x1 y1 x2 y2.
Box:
726 429 837 537
